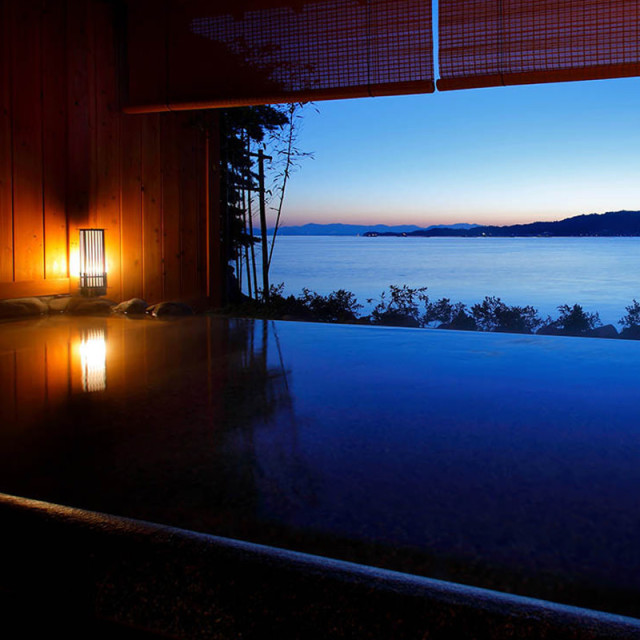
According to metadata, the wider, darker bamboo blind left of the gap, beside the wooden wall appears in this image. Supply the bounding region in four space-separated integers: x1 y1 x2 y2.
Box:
128 0 434 110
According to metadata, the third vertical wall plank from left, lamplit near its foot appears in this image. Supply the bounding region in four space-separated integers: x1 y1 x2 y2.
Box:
42 0 68 278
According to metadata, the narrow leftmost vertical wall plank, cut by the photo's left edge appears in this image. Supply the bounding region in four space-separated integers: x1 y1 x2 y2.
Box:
0 0 13 282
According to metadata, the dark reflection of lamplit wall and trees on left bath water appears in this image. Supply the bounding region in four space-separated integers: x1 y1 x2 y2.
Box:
0 316 312 543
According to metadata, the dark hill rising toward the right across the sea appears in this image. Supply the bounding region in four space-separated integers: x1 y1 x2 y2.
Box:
365 211 640 238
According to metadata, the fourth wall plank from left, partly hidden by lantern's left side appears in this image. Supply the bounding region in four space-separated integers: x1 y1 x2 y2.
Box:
67 0 91 278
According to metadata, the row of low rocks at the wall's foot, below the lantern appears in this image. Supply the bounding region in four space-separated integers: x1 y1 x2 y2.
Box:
0 295 194 320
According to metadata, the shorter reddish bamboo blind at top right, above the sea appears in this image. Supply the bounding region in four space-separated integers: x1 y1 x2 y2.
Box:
438 0 640 91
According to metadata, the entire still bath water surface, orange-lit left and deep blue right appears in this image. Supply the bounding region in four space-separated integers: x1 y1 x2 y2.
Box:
0 316 640 617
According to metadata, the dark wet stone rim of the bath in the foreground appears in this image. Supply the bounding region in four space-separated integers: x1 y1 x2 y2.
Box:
0 494 640 640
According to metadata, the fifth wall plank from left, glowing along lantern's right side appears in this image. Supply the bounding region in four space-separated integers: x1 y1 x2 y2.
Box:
93 3 122 300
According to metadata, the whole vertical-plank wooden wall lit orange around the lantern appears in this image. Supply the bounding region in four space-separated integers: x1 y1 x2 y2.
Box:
0 0 215 303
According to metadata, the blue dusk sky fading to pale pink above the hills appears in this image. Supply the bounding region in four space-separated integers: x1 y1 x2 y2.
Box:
283 78 640 226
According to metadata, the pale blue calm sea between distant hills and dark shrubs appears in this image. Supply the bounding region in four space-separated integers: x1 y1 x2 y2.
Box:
244 236 640 324
